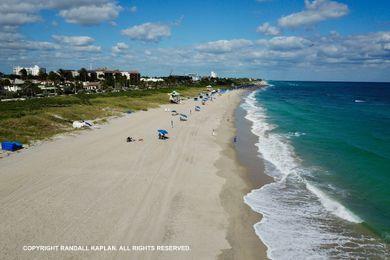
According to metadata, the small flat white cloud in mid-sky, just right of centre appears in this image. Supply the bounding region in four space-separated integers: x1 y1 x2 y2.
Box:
196 39 253 53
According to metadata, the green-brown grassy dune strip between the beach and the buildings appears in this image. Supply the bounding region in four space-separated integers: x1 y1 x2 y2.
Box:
0 87 209 143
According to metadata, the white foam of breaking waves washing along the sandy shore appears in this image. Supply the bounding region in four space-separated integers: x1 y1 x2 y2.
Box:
242 90 384 259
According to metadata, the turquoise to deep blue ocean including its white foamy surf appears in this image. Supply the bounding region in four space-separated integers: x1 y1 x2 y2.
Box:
241 81 390 259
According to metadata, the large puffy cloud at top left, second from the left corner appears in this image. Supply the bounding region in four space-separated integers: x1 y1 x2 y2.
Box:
59 3 122 25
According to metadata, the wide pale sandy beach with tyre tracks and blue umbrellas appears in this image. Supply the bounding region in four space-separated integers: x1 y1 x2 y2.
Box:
0 91 266 259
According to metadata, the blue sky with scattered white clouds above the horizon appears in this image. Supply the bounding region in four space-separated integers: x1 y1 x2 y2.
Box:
0 0 390 81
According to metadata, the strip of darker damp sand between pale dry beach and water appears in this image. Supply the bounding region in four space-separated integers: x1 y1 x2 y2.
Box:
215 89 267 259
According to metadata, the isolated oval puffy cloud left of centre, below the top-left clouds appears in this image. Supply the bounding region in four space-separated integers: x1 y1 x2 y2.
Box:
122 23 171 42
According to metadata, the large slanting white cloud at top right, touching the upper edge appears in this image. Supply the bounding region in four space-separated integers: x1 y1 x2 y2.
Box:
278 0 349 27
